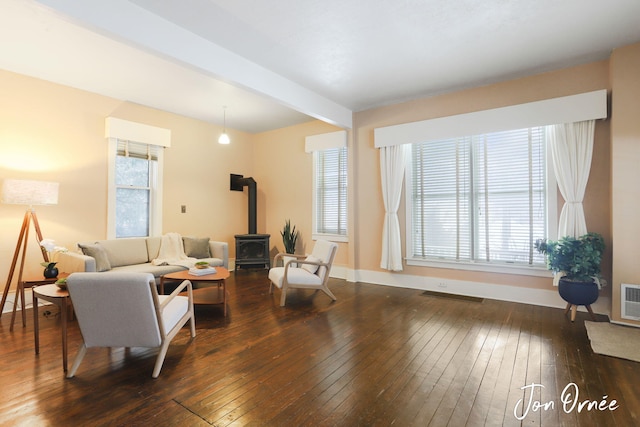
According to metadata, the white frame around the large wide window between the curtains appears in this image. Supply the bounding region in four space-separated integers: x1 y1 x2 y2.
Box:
404 129 558 277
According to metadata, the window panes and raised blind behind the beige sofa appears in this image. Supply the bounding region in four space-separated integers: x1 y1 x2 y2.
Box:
115 140 162 238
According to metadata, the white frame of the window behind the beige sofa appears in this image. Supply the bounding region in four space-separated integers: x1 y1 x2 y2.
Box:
107 138 164 239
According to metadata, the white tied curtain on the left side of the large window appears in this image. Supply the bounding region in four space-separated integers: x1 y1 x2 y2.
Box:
380 145 409 271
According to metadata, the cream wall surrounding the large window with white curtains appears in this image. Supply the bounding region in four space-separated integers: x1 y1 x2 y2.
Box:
354 61 611 292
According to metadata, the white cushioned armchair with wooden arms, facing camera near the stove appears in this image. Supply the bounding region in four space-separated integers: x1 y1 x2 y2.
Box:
269 240 338 306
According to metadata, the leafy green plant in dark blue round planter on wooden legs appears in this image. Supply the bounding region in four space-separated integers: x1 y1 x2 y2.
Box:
535 233 606 322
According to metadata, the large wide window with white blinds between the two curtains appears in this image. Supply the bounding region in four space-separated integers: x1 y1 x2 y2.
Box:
407 127 547 265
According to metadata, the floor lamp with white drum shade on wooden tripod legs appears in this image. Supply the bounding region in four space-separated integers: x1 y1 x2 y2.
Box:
0 179 59 316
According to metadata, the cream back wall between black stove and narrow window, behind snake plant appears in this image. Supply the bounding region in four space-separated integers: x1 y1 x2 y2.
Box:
253 120 350 267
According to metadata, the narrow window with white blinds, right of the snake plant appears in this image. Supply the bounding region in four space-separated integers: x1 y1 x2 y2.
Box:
313 147 347 237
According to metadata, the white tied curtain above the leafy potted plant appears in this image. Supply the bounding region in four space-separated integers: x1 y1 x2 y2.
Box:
547 120 595 237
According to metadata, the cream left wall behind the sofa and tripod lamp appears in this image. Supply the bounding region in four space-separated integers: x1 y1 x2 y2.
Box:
0 71 253 286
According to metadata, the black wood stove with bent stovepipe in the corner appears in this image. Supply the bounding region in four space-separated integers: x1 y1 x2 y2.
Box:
230 174 271 270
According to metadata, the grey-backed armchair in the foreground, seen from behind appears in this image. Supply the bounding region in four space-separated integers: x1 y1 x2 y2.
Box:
67 272 196 378
